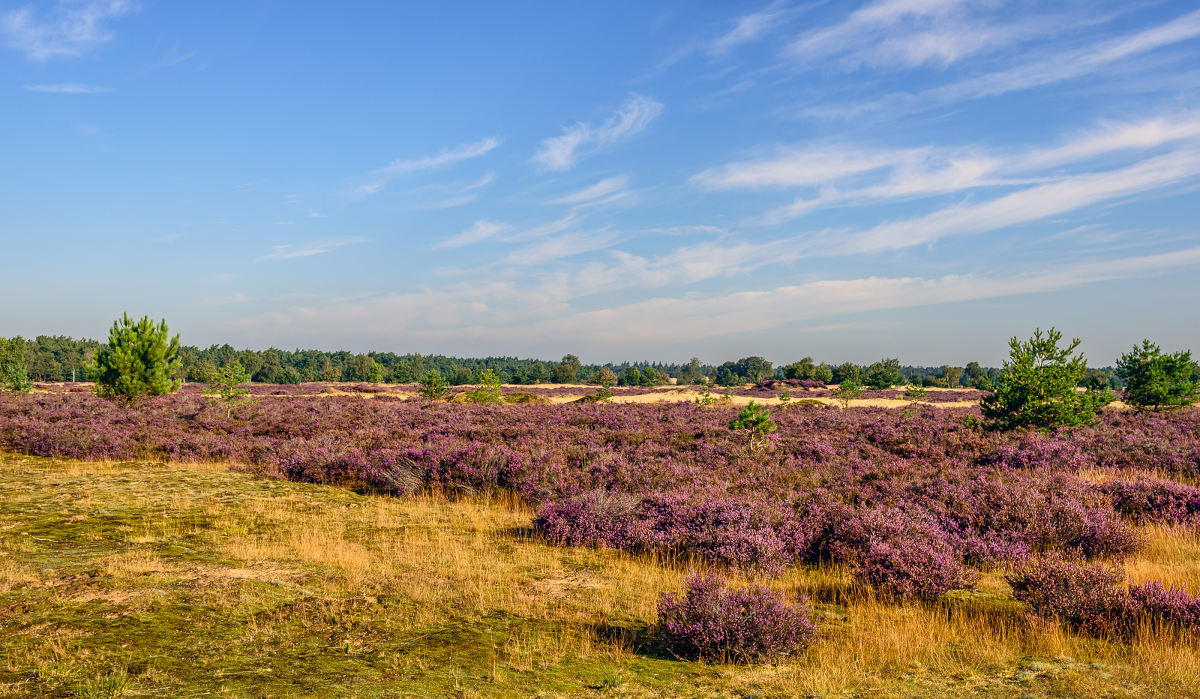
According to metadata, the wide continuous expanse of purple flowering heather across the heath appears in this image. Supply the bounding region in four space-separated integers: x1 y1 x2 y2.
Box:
0 384 1200 599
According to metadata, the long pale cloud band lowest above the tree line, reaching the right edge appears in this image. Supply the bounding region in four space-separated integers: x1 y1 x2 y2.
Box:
223 247 1200 352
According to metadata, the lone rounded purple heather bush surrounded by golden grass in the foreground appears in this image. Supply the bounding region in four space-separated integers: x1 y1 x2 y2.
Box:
659 575 816 663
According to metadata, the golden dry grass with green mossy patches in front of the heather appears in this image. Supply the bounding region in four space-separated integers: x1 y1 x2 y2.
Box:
0 456 1200 697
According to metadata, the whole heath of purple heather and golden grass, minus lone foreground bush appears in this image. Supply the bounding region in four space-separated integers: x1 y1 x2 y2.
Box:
0 384 1200 697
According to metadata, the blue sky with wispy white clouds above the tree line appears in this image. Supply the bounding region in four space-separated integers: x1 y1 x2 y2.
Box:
0 0 1200 365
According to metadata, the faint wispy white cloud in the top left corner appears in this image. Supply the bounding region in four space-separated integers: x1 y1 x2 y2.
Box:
0 0 136 61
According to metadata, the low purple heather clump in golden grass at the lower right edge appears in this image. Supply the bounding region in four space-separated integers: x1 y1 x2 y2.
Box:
1008 557 1200 635
